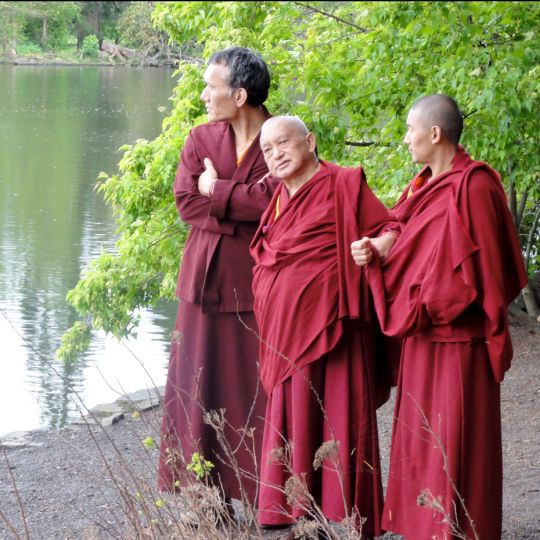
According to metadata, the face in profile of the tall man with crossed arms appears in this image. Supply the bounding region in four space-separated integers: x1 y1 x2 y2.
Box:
201 64 238 122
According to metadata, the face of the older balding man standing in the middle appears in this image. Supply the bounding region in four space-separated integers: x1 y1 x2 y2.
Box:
261 120 315 180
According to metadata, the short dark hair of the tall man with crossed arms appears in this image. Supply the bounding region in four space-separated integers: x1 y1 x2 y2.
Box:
208 47 270 107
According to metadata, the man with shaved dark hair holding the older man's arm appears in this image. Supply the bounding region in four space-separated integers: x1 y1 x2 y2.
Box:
352 94 527 540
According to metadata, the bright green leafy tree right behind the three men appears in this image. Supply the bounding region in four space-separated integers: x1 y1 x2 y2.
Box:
58 2 540 358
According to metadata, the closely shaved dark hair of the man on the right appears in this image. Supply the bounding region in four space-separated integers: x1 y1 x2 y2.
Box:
411 94 463 146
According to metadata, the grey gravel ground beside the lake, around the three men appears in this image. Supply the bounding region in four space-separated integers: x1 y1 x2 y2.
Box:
0 318 540 540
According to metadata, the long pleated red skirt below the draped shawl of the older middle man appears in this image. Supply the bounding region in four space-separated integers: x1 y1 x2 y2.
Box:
258 330 382 534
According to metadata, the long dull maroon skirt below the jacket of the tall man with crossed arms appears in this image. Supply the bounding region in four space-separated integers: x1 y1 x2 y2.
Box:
158 301 266 502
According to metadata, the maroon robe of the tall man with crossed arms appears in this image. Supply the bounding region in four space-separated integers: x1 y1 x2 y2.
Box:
159 116 276 500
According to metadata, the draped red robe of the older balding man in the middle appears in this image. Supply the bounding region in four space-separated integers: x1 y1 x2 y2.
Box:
251 163 394 533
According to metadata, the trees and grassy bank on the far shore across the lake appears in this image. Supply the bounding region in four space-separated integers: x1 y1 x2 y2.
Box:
0 1 183 66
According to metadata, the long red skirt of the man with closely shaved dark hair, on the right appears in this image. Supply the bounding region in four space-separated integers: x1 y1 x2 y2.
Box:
383 338 502 540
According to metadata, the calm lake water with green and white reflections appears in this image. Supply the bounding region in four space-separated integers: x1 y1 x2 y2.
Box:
0 65 176 435
